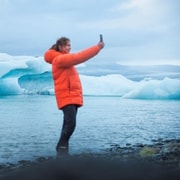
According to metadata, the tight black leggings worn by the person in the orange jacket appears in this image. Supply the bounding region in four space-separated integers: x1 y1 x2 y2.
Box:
56 104 78 151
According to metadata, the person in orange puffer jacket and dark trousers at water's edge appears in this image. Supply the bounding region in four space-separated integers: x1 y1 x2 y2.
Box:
44 37 104 157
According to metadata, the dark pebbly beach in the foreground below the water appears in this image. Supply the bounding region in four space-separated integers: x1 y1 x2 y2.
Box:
0 139 180 180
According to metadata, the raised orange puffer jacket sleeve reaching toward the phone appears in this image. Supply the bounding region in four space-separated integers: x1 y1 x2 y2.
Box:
53 45 101 68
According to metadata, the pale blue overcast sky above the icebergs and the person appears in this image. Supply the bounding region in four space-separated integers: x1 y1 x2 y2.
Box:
0 0 180 65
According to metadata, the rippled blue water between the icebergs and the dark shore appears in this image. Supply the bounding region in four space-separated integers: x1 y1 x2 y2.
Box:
0 95 180 163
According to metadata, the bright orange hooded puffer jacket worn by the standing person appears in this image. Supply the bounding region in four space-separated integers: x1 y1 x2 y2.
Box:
44 45 101 109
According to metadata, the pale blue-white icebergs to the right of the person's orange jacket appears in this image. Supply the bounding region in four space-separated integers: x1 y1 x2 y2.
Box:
81 75 180 99
